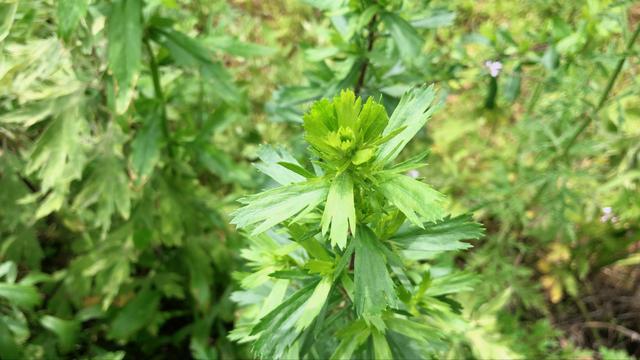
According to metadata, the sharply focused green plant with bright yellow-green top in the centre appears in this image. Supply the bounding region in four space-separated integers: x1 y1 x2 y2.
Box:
232 86 482 359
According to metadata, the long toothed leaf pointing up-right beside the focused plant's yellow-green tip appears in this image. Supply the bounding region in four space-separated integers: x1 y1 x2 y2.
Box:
377 85 437 165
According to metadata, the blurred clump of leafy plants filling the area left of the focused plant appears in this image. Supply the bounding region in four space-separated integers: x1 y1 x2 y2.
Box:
0 0 272 359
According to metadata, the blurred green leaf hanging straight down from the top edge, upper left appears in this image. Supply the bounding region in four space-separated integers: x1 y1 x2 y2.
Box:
107 0 142 114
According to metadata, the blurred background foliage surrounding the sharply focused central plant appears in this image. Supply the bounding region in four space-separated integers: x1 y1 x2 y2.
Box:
0 0 640 359
